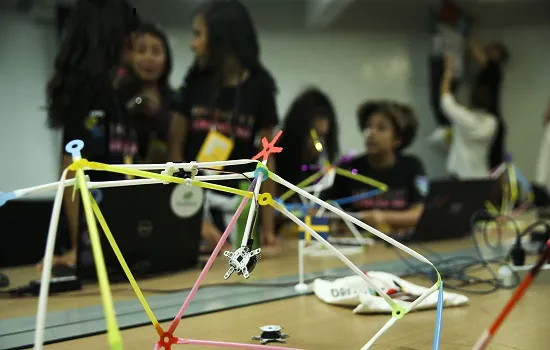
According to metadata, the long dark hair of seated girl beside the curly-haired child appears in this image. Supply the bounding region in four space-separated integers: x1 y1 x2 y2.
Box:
277 87 339 177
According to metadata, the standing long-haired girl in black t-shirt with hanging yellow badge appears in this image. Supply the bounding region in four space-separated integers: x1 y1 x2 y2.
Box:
170 0 278 252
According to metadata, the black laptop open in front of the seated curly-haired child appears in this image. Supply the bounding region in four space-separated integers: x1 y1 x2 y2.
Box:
409 179 500 241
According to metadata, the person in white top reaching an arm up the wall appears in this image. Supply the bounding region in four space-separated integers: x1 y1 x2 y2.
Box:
441 56 498 179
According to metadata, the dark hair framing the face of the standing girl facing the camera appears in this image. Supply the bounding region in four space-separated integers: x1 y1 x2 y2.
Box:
118 23 173 99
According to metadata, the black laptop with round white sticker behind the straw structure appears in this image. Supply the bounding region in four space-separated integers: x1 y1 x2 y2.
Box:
76 184 204 282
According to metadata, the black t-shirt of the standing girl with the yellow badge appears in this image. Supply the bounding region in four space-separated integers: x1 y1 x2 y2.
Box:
179 75 278 190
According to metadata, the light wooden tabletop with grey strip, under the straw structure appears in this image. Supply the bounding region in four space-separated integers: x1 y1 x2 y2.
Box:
0 226 550 350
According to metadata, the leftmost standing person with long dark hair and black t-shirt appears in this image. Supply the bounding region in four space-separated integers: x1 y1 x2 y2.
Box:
39 0 139 266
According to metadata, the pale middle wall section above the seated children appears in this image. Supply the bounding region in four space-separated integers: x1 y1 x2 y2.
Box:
167 27 445 177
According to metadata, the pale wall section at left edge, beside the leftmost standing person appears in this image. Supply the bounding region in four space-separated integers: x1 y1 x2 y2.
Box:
0 12 60 197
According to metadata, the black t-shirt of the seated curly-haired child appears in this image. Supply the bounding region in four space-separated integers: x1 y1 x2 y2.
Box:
326 155 426 212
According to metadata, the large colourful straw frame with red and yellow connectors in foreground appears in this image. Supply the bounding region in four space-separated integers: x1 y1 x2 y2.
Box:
0 132 443 350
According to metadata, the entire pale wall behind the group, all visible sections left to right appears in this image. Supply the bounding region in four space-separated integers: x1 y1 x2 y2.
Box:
0 1 550 197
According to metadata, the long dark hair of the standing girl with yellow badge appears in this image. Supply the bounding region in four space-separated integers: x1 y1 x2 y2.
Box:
185 0 276 91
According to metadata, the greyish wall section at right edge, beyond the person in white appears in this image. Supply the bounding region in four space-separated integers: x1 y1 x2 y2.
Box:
480 26 550 179
